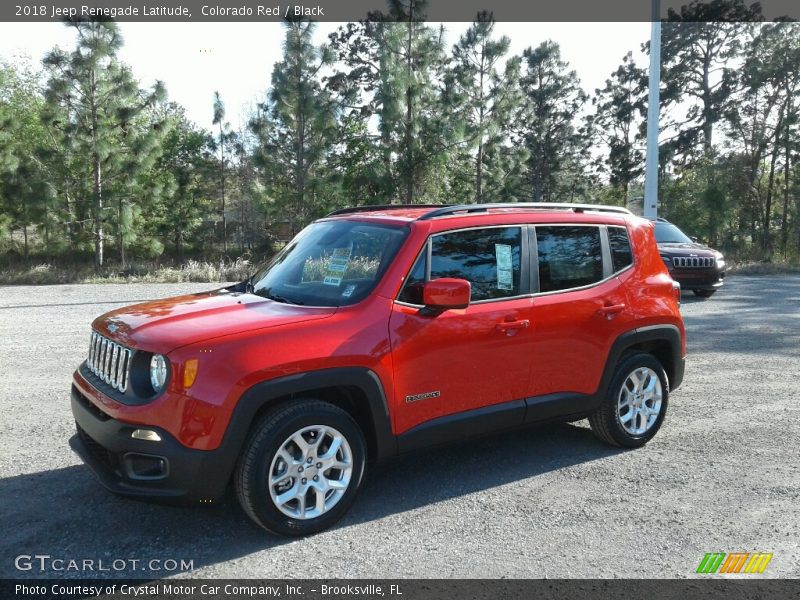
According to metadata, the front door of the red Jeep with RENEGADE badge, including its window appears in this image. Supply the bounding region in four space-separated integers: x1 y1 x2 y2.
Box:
389 226 533 433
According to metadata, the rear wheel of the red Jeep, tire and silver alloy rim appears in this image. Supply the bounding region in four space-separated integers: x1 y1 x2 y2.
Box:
589 352 669 448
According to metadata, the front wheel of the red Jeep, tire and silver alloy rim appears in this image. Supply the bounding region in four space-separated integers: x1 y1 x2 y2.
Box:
234 399 366 536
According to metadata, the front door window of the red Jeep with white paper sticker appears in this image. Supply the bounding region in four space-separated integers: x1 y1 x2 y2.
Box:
431 227 522 302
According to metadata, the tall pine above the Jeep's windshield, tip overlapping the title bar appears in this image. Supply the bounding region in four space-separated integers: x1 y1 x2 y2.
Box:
326 0 460 203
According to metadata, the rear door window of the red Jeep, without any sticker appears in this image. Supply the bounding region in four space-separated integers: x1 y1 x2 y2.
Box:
536 225 603 292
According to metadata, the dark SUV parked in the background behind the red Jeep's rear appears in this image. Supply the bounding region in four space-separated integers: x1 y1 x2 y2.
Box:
656 217 725 298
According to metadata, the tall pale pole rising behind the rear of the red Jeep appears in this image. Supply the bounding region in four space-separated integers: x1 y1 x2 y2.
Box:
643 0 661 219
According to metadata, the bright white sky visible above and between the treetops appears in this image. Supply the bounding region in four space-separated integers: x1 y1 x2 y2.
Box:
0 22 650 129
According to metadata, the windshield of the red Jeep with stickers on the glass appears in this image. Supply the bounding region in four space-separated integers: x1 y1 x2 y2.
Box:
248 220 408 306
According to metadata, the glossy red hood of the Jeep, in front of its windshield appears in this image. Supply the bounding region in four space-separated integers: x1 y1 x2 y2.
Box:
92 289 336 354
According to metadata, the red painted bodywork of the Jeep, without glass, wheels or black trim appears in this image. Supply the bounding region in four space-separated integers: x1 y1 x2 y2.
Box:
74 208 685 449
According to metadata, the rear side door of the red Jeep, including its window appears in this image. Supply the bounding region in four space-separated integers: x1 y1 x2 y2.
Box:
529 225 633 408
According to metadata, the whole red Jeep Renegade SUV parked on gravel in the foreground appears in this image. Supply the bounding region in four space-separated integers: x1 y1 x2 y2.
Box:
71 204 685 535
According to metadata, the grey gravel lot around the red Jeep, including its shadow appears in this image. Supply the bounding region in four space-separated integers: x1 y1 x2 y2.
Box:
0 276 800 578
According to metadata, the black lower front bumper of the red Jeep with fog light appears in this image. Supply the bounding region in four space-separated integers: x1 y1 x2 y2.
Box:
70 385 233 503
